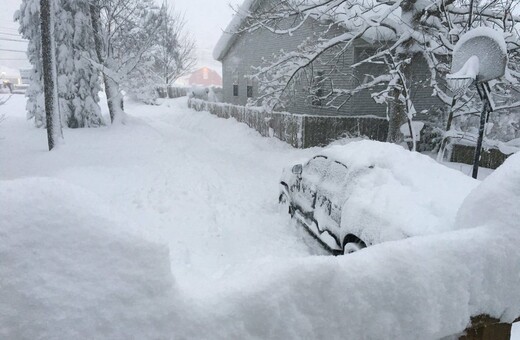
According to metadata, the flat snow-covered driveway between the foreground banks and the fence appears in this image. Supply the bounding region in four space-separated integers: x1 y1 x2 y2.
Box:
0 97 313 290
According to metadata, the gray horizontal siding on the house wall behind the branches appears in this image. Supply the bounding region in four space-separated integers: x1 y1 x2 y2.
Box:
222 12 444 119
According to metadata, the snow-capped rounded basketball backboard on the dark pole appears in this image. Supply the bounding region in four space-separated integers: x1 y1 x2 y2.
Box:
451 27 507 83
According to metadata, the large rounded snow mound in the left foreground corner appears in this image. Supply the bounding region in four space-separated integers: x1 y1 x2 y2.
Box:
0 178 174 339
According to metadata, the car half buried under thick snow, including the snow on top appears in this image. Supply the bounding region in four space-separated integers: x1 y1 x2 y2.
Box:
279 141 478 254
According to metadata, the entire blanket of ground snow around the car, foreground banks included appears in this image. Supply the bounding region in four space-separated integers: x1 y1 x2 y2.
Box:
0 96 520 339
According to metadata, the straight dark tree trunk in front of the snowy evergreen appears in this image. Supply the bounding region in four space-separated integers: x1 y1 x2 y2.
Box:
40 0 62 150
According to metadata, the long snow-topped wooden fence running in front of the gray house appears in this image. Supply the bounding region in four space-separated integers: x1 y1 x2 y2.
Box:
188 98 388 148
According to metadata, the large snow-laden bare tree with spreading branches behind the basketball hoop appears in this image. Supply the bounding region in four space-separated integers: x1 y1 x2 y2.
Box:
237 0 520 149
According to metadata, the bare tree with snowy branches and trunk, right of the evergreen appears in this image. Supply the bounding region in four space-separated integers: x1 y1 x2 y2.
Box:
90 0 162 123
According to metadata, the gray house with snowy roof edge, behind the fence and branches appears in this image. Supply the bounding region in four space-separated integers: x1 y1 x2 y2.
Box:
213 0 442 122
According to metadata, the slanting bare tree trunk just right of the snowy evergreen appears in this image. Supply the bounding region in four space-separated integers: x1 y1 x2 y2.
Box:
90 1 124 124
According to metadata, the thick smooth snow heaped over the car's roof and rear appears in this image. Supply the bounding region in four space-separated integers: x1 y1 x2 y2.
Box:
321 140 479 244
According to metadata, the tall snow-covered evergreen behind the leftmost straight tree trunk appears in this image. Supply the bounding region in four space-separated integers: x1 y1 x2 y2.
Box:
15 0 102 128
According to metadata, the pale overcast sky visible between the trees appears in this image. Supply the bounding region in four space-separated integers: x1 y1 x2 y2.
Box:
0 0 242 73
